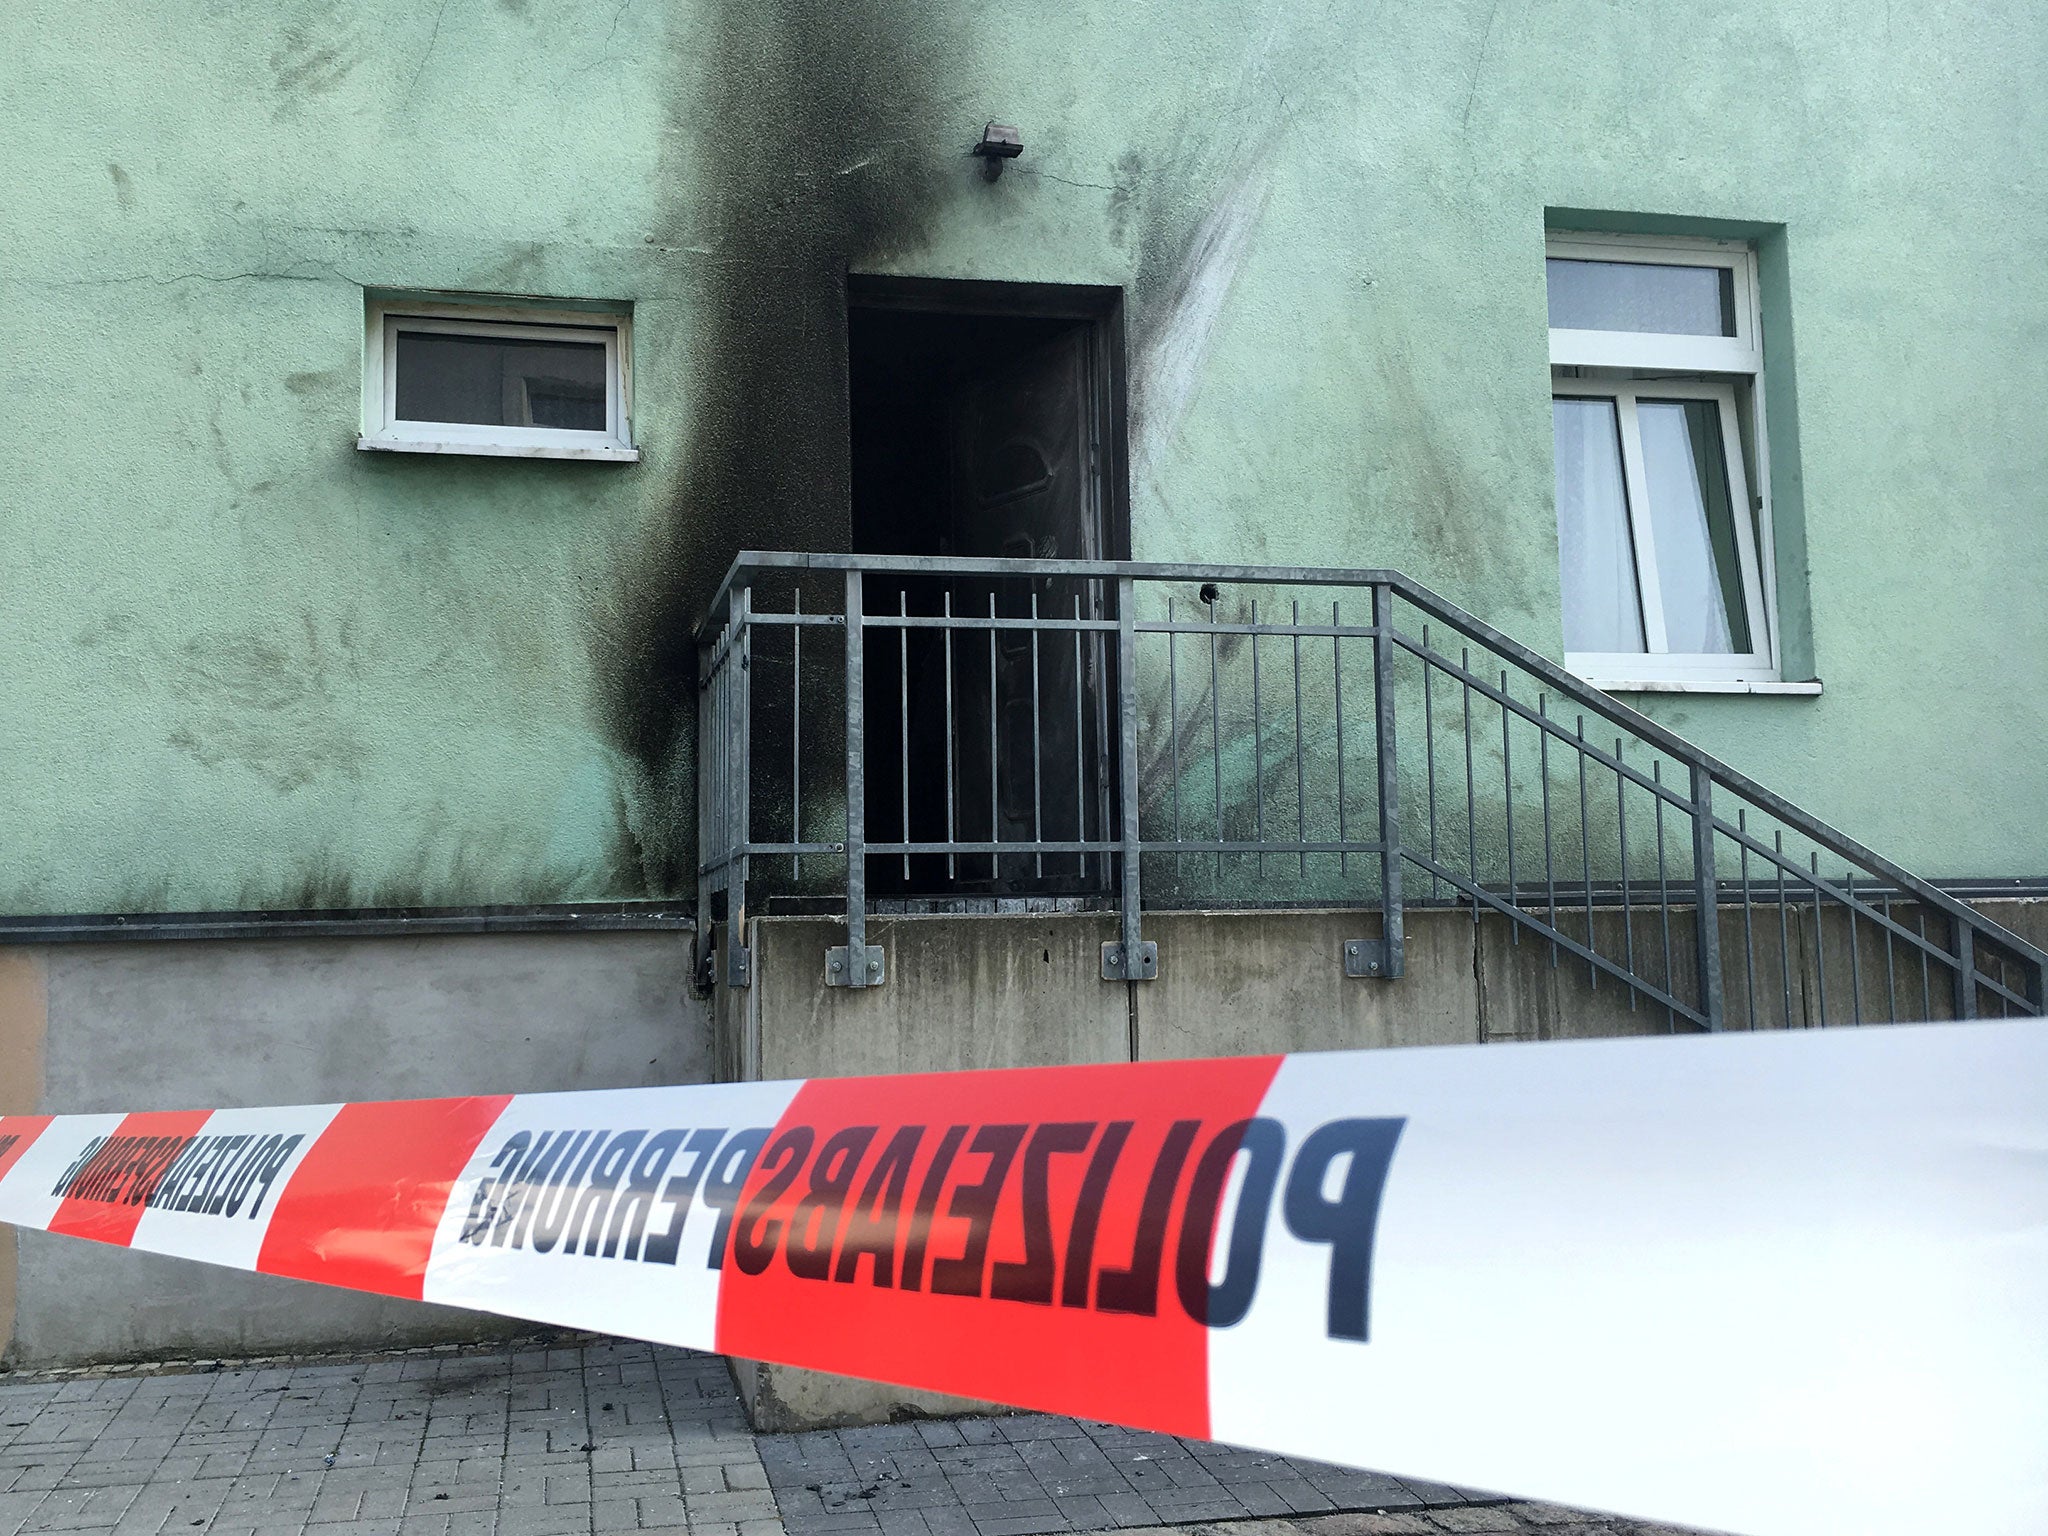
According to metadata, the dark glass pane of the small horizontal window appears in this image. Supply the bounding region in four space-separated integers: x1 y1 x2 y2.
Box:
397 330 604 432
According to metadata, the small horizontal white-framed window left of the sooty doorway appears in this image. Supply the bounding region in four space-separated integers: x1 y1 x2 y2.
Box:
356 301 639 461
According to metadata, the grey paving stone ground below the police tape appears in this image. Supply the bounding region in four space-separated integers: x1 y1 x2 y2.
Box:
0 1337 1695 1536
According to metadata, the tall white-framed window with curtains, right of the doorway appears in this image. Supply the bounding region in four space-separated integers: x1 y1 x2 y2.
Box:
1546 233 1778 688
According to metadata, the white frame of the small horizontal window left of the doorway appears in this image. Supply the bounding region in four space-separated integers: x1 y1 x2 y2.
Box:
356 301 639 463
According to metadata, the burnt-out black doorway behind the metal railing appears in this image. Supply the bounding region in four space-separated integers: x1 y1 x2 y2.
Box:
848 276 1130 897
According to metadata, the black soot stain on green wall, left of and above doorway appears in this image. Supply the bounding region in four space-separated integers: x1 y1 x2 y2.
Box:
592 0 979 895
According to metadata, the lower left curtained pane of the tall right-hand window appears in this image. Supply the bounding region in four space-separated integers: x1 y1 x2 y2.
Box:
1550 399 1647 651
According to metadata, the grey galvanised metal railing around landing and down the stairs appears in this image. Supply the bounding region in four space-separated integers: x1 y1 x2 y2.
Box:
698 553 2048 1030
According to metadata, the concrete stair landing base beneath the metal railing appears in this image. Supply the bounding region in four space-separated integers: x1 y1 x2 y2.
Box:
721 901 2048 1432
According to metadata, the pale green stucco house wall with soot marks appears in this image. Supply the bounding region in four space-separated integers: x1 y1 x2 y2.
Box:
0 0 2048 911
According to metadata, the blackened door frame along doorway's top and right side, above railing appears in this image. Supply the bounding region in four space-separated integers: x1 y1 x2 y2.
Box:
846 272 1130 559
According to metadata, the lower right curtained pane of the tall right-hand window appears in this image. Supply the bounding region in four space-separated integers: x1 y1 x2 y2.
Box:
1636 399 1753 655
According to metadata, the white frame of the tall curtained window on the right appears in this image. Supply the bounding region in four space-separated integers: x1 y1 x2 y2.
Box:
1544 233 1780 688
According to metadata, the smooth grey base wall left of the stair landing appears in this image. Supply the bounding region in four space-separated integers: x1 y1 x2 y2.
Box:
0 932 711 1364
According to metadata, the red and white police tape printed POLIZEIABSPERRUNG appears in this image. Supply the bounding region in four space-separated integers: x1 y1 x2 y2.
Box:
0 1022 2048 1536
